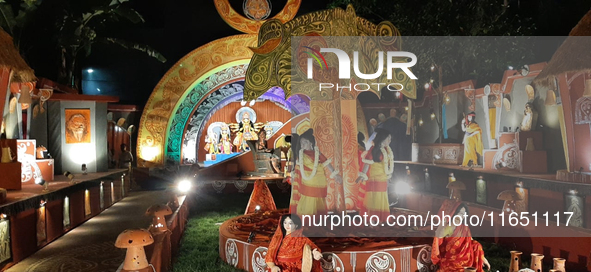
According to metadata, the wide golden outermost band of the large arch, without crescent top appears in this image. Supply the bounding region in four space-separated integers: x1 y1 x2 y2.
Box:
137 34 257 167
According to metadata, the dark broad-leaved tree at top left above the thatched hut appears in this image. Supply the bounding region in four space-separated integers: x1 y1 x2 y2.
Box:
0 0 166 88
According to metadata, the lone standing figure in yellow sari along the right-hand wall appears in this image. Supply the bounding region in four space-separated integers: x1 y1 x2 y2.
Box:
462 112 483 166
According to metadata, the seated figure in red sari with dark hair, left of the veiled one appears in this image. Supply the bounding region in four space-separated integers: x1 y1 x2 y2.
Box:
265 214 322 272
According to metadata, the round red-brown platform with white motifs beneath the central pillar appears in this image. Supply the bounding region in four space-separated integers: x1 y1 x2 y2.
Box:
219 209 435 272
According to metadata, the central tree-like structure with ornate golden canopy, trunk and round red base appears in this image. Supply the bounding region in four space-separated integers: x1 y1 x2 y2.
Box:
213 3 444 271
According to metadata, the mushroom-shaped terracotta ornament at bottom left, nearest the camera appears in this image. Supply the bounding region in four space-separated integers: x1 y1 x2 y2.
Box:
115 229 154 271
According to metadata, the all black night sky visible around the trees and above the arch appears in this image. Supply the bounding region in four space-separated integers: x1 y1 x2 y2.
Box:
27 0 591 108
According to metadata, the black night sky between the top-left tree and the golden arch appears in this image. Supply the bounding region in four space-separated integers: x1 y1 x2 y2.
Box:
78 0 329 108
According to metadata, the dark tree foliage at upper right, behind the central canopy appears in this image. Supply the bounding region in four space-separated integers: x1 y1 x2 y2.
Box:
329 0 564 93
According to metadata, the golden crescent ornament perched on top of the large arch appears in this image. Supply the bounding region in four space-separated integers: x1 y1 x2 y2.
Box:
215 0 302 34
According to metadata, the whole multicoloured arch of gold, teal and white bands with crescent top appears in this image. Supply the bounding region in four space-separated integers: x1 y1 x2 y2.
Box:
137 0 301 167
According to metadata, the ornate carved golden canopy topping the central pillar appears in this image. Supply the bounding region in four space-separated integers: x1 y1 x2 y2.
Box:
244 5 416 100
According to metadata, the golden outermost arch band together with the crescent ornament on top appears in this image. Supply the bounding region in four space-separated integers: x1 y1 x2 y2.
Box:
137 0 301 167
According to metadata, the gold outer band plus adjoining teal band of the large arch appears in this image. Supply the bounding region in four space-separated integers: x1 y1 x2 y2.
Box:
137 34 257 167
